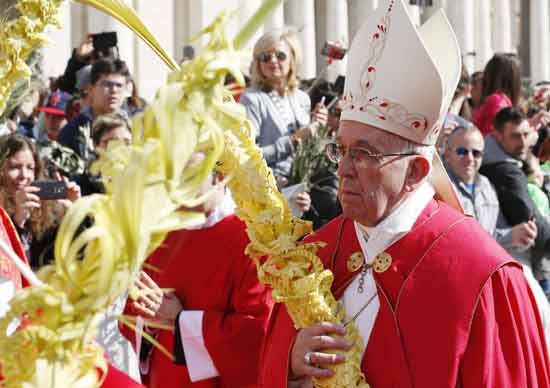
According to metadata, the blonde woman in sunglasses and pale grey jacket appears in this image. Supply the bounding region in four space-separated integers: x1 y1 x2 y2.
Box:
240 29 328 211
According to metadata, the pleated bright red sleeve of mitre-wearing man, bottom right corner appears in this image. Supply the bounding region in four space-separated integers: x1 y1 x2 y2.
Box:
460 266 550 388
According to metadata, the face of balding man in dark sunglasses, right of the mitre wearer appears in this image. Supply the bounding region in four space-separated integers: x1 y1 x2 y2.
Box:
445 129 485 184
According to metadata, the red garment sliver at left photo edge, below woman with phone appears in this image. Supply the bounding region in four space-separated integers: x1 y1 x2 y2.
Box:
0 208 29 290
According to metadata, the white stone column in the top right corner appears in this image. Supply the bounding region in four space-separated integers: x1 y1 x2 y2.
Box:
530 0 550 83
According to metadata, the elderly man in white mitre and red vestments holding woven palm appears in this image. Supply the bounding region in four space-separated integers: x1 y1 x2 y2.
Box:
260 0 550 388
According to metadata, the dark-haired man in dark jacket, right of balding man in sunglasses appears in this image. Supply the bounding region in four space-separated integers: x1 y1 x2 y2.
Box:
480 108 550 267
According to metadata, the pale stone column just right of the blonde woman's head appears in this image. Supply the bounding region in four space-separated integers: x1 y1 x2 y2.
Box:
284 0 317 79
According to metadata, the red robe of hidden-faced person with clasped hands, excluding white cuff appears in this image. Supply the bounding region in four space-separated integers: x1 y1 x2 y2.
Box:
123 216 272 388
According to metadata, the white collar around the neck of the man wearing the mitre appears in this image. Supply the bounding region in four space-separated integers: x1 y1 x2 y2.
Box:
354 180 435 263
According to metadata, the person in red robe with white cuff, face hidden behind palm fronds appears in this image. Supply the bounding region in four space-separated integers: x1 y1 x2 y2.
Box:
125 166 272 388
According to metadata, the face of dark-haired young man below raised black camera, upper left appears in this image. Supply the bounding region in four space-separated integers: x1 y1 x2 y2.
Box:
88 74 126 115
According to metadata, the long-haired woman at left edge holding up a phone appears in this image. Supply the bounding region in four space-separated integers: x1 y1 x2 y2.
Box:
0 134 80 267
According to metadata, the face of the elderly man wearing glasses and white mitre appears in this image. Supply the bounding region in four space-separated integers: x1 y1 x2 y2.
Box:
338 120 418 226
